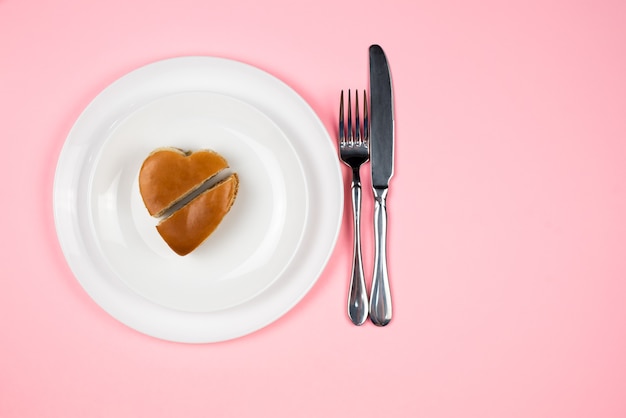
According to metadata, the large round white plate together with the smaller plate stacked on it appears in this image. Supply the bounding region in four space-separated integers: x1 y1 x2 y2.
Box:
53 57 343 342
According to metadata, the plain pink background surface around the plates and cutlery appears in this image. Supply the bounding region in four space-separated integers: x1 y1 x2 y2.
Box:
0 0 626 418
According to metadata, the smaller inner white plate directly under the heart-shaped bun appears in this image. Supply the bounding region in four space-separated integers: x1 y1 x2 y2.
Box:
88 92 308 312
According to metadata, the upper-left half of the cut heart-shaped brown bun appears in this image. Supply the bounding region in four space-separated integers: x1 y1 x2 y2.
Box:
139 148 228 217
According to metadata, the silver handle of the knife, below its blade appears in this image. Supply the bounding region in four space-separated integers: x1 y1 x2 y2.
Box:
370 188 391 327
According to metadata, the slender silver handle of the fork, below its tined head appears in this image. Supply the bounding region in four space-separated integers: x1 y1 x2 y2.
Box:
348 169 368 325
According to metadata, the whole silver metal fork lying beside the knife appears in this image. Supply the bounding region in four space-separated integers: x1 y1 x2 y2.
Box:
339 90 370 325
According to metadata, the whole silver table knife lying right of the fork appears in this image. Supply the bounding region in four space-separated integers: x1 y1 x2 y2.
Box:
369 45 394 326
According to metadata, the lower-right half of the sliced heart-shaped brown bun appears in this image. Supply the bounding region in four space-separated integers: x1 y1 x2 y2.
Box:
157 173 239 255
